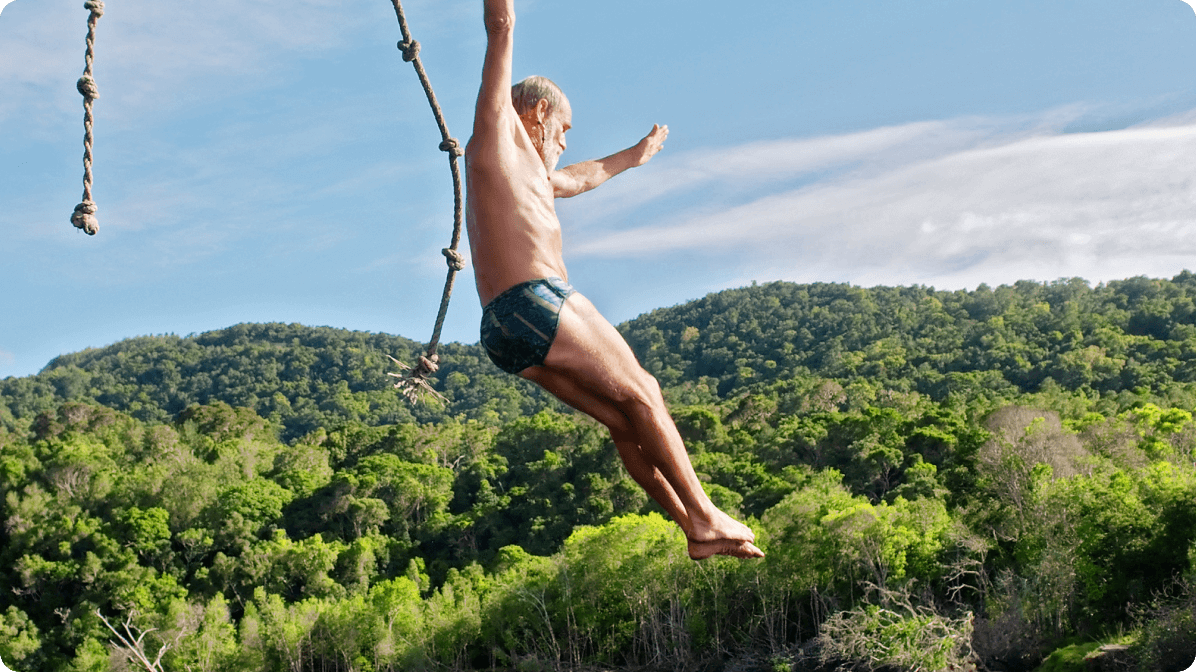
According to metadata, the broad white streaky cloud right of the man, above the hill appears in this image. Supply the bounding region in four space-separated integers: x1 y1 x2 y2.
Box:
572 111 1196 287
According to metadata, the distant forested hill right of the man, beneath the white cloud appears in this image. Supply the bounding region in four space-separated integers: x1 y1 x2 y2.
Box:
623 271 1196 399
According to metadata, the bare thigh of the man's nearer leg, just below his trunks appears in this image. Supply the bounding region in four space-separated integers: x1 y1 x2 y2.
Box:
544 293 654 403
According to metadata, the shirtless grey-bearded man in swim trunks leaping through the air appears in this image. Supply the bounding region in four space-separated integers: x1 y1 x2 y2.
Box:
465 0 764 560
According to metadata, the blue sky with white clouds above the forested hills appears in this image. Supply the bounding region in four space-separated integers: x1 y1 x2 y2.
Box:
0 0 1196 378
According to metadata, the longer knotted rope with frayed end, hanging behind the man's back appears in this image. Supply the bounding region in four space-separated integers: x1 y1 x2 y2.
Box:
386 0 465 404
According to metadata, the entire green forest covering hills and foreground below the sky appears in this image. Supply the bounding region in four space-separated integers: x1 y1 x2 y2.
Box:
0 273 1196 672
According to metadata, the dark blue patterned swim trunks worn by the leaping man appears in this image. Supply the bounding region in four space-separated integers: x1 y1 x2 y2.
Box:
482 277 574 373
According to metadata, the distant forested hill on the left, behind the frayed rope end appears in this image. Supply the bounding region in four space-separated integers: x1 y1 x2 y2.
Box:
0 323 556 440
